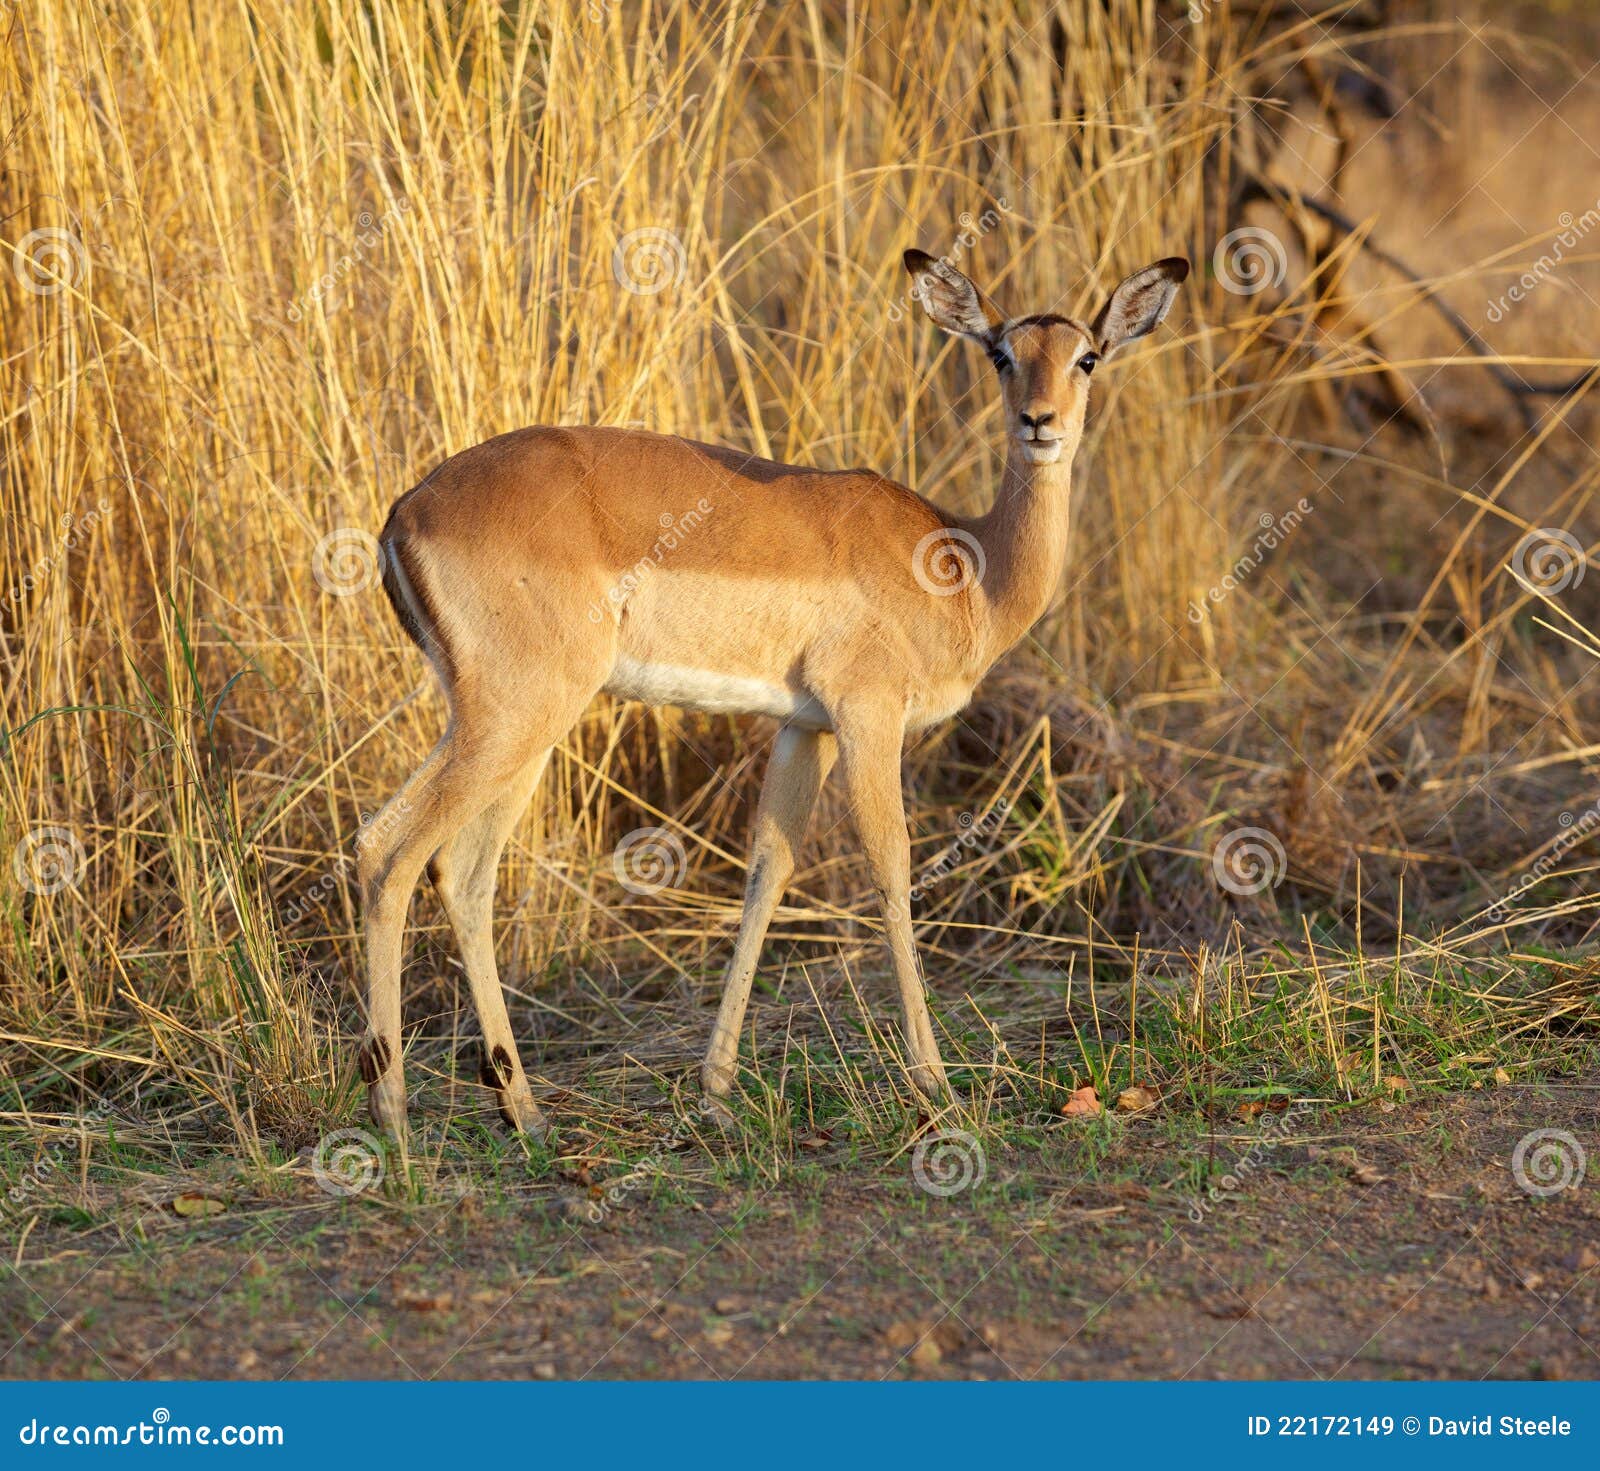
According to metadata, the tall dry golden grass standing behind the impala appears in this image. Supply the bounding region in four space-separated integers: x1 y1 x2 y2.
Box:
0 0 1594 1141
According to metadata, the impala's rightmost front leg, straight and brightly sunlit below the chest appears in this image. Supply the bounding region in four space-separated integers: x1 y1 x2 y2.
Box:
838 712 947 1100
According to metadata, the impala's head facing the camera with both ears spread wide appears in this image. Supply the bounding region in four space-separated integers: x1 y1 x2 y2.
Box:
906 250 1189 464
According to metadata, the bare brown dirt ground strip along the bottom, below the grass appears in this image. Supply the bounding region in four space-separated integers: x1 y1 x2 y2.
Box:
0 1087 1600 1378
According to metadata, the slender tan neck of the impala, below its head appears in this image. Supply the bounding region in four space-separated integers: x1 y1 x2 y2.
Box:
973 440 1077 661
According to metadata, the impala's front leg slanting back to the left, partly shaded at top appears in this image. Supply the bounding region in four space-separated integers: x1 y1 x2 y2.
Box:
701 725 837 1098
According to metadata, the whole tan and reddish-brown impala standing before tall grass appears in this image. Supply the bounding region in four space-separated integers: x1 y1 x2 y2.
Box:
358 250 1189 1136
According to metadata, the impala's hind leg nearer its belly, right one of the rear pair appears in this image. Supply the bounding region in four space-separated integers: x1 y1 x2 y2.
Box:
427 748 550 1135
